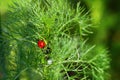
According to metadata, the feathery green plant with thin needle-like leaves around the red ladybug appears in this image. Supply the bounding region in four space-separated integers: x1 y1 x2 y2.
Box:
1 0 109 80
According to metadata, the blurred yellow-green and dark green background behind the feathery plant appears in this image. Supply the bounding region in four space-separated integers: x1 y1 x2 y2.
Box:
0 0 120 80
